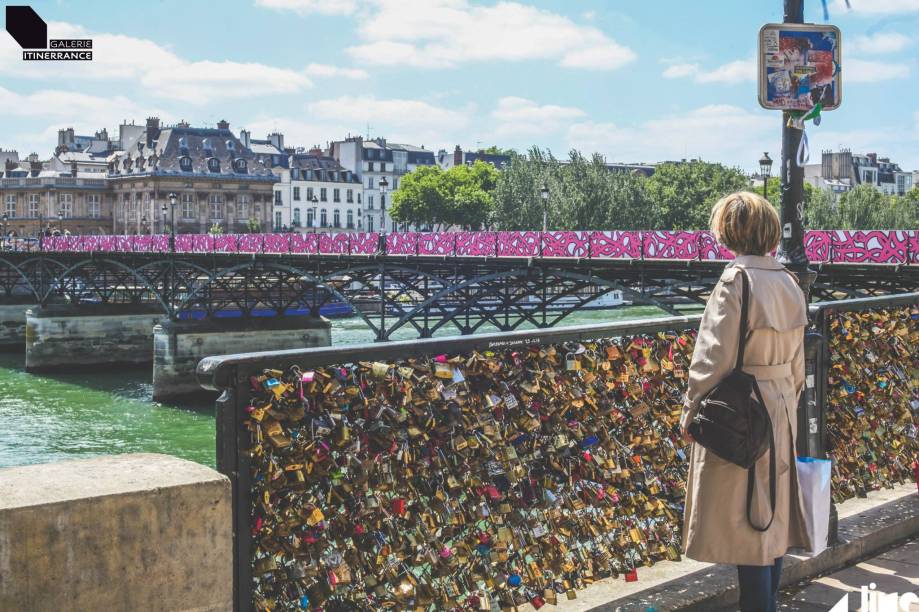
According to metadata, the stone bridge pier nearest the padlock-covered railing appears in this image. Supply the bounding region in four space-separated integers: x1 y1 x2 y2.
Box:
153 316 332 401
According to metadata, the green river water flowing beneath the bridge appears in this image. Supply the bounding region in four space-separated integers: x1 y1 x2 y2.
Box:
0 306 676 467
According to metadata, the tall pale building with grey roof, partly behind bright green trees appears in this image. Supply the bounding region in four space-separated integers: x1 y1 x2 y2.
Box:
329 136 436 232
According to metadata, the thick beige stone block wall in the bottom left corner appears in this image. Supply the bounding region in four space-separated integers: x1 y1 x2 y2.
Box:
0 454 233 612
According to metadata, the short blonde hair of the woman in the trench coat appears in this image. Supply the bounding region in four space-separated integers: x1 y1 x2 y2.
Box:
710 191 782 255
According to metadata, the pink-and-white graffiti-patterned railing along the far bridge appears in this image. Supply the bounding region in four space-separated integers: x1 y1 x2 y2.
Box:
14 230 919 264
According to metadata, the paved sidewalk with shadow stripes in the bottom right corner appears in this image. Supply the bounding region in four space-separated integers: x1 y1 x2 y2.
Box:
779 537 919 612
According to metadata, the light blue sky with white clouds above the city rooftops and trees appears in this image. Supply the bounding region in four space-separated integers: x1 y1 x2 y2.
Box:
0 0 919 170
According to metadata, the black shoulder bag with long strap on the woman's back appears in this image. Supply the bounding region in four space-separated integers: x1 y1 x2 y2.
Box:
687 266 775 531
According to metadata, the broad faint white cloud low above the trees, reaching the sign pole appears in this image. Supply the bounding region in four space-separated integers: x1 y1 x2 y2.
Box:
567 104 781 167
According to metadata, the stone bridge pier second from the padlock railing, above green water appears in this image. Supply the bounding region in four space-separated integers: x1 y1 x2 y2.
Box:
26 304 162 372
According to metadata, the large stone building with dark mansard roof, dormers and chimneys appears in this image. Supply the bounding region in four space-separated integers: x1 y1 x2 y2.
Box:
107 117 277 234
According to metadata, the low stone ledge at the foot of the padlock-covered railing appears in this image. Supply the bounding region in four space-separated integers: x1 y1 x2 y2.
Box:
548 483 919 612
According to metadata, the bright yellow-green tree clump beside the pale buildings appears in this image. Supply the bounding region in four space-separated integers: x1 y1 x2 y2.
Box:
389 161 498 229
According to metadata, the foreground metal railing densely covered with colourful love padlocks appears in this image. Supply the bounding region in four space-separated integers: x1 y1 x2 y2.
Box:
198 294 919 609
